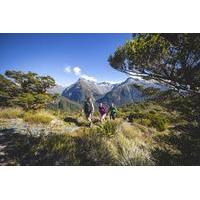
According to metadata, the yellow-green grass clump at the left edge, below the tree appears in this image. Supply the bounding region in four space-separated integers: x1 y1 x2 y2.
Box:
0 108 24 119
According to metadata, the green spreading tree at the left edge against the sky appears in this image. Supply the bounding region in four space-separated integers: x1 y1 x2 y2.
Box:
0 70 55 109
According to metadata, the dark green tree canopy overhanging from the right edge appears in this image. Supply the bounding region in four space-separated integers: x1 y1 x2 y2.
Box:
108 33 200 92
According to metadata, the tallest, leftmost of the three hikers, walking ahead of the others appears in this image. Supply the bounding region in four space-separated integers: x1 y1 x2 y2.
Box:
84 97 94 127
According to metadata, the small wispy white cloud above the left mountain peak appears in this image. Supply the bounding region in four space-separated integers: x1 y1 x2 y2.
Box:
64 66 97 82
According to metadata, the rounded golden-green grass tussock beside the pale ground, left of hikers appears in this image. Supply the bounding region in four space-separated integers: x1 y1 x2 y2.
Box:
24 110 55 124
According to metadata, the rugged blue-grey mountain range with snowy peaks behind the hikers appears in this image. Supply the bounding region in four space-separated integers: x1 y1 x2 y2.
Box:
49 77 167 106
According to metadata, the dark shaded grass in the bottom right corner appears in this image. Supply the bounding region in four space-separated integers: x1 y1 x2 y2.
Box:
152 125 200 166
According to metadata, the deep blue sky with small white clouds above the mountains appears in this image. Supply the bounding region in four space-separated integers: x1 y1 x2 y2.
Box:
0 34 131 86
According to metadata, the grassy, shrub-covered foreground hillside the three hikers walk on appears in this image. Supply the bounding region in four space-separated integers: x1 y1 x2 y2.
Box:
0 91 200 165
